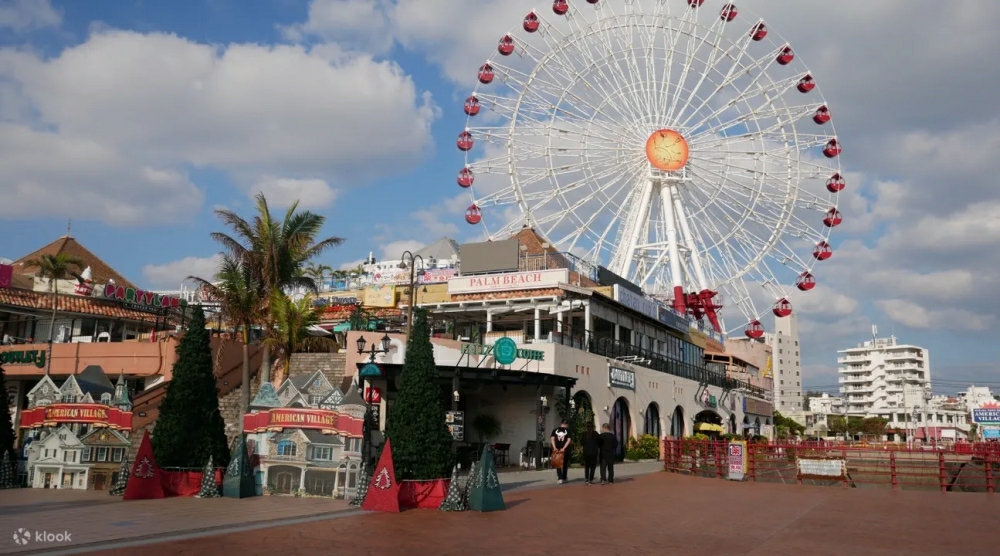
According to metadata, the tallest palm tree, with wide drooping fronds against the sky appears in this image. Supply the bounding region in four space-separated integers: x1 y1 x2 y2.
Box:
212 193 344 382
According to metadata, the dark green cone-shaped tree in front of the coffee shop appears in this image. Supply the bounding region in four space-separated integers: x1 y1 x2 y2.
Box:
386 310 454 480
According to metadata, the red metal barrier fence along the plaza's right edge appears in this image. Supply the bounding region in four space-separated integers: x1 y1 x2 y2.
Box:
662 439 1000 493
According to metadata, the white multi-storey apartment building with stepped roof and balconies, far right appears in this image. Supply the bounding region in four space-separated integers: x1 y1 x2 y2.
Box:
837 336 931 413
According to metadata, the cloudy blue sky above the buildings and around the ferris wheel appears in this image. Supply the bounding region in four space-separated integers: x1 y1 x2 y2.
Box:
0 0 1000 393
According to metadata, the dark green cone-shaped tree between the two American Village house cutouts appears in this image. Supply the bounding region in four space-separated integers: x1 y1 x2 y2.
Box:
153 306 229 469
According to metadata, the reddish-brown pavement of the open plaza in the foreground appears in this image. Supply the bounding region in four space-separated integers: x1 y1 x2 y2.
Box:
86 473 1000 556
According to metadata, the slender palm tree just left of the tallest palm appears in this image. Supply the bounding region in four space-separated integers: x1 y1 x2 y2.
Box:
188 253 262 413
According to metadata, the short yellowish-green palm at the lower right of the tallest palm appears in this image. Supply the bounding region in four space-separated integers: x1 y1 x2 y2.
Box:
264 291 336 379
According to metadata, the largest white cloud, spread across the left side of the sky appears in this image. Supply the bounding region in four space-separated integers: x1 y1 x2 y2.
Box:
0 30 439 224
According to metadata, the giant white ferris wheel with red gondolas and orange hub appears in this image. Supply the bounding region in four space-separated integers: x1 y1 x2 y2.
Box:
457 0 845 338
